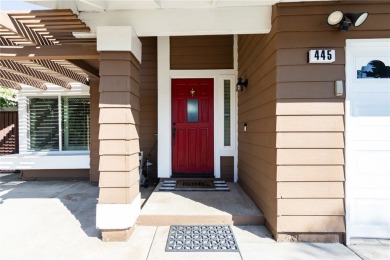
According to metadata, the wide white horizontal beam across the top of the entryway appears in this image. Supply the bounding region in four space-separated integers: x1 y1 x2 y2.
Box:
79 6 272 37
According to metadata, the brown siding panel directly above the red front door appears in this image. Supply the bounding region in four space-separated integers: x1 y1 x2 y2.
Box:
170 35 233 70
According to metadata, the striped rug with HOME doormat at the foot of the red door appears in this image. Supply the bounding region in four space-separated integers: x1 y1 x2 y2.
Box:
159 179 230 191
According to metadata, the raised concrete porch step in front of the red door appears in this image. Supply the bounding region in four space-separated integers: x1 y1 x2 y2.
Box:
137 183 265 226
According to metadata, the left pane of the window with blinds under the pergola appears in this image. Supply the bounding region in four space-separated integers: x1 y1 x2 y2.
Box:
29 98 59 151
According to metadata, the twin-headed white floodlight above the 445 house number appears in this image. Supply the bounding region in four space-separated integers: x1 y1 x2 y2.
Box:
328 11 368 31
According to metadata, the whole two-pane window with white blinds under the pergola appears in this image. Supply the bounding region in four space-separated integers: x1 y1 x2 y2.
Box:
29 97 90 151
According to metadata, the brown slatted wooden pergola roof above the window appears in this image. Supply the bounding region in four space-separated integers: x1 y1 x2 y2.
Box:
0 10 99 90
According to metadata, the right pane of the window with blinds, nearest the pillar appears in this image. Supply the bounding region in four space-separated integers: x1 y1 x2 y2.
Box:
61 97 89 151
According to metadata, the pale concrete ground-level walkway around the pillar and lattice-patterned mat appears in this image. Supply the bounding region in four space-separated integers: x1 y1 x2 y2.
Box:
0 174 388 260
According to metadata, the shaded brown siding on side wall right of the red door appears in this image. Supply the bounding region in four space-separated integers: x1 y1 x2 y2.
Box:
238 20 277 230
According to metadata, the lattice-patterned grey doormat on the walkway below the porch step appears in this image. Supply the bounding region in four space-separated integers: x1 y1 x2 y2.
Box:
165 225 239 252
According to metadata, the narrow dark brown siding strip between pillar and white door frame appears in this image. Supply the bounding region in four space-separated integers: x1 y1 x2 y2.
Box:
140 37 157 181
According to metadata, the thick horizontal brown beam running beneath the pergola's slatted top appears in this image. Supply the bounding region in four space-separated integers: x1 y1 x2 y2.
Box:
0 44 99 60
